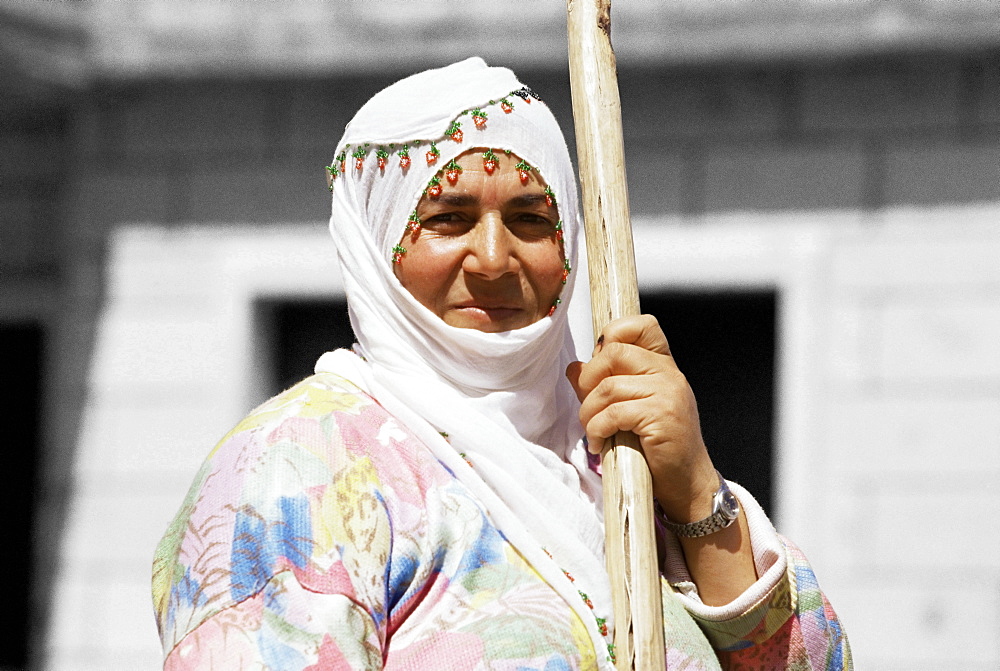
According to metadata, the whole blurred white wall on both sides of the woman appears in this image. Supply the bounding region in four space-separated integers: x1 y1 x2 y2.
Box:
47 205 1000 671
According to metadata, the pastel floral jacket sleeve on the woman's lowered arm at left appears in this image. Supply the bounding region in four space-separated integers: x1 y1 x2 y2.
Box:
154 380 392 671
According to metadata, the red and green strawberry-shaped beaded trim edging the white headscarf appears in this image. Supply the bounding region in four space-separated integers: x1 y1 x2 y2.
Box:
326 86 572 316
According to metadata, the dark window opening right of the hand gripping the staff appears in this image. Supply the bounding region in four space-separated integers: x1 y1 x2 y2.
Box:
641 291 777 513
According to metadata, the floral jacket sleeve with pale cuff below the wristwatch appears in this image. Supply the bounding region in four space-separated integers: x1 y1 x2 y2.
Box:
665 483 853 671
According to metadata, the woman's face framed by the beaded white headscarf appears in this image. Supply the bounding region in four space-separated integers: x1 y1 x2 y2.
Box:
395 149 563 333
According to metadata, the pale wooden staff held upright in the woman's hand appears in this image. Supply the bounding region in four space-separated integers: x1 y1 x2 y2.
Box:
566 0 666 671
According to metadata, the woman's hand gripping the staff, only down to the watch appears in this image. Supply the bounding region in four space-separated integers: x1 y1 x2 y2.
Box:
566 315 719 523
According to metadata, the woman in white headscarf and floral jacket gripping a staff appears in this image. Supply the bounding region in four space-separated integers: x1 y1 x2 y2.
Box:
154 59 850 671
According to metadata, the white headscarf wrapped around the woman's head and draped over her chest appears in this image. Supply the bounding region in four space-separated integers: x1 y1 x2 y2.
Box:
316 58 613 668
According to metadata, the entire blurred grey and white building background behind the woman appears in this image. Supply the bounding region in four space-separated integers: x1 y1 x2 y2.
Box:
0 0 1000 671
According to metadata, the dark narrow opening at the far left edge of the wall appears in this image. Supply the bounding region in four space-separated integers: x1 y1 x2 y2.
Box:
0 324 43 669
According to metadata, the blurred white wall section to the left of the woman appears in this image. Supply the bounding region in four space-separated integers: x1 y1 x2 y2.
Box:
46 225 339 671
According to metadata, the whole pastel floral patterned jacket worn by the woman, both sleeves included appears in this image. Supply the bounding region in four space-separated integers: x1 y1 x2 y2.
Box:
153 373 851 671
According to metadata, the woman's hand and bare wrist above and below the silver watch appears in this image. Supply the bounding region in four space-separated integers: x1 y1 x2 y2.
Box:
566 315 757 606
